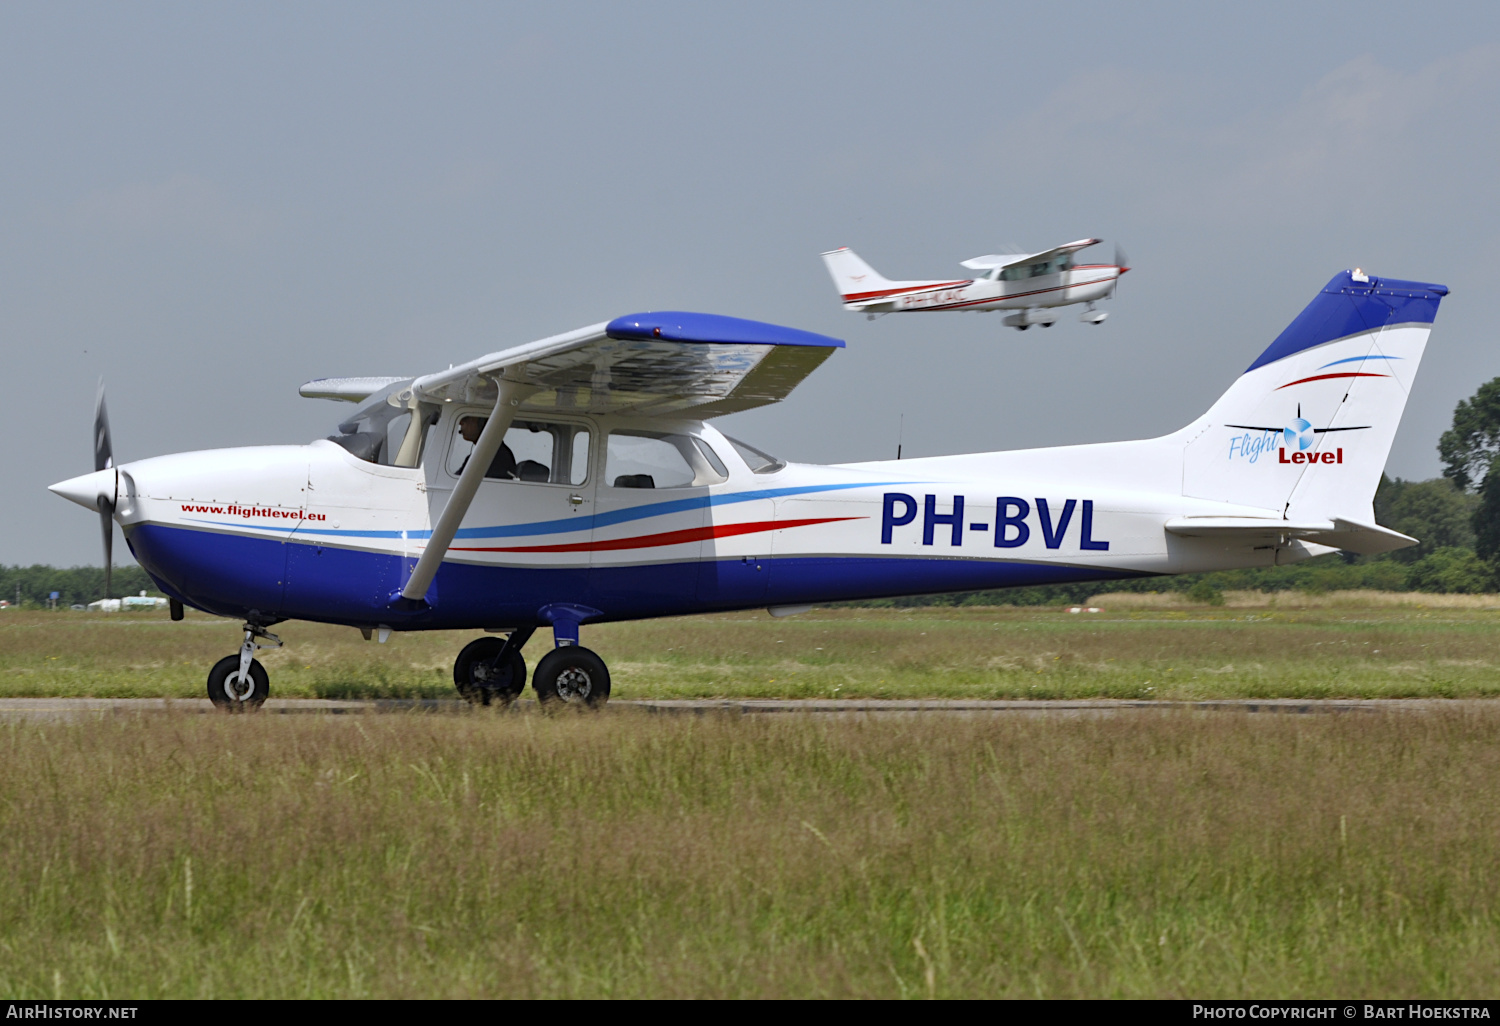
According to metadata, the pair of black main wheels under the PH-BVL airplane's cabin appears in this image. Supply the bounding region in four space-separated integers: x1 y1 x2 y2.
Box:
453 624 609 708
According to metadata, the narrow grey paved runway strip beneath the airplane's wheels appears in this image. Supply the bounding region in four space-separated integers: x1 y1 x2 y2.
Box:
0 698 1482 720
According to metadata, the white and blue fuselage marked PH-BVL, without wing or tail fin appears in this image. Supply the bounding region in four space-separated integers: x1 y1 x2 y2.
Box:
78 405 1290 630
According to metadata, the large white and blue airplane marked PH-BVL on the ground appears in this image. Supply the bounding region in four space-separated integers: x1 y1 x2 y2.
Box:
51 270 1448 708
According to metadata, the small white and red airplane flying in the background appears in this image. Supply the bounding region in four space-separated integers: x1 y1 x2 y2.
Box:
824 239 1130 332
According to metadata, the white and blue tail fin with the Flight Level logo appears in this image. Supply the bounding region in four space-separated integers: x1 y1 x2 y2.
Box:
1176 270 1448 528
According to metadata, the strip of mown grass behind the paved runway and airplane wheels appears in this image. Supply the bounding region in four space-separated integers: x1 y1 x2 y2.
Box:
0 594 1500 699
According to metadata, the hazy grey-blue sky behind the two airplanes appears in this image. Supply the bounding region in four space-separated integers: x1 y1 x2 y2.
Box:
0 0 1500 566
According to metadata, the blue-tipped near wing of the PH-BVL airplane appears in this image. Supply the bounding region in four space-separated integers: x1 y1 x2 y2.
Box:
405 311 843 419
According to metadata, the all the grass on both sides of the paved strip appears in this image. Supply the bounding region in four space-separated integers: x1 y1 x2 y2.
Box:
0 594 1500 998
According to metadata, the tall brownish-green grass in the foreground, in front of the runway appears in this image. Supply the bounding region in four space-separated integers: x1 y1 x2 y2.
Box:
0 710 1500 998
